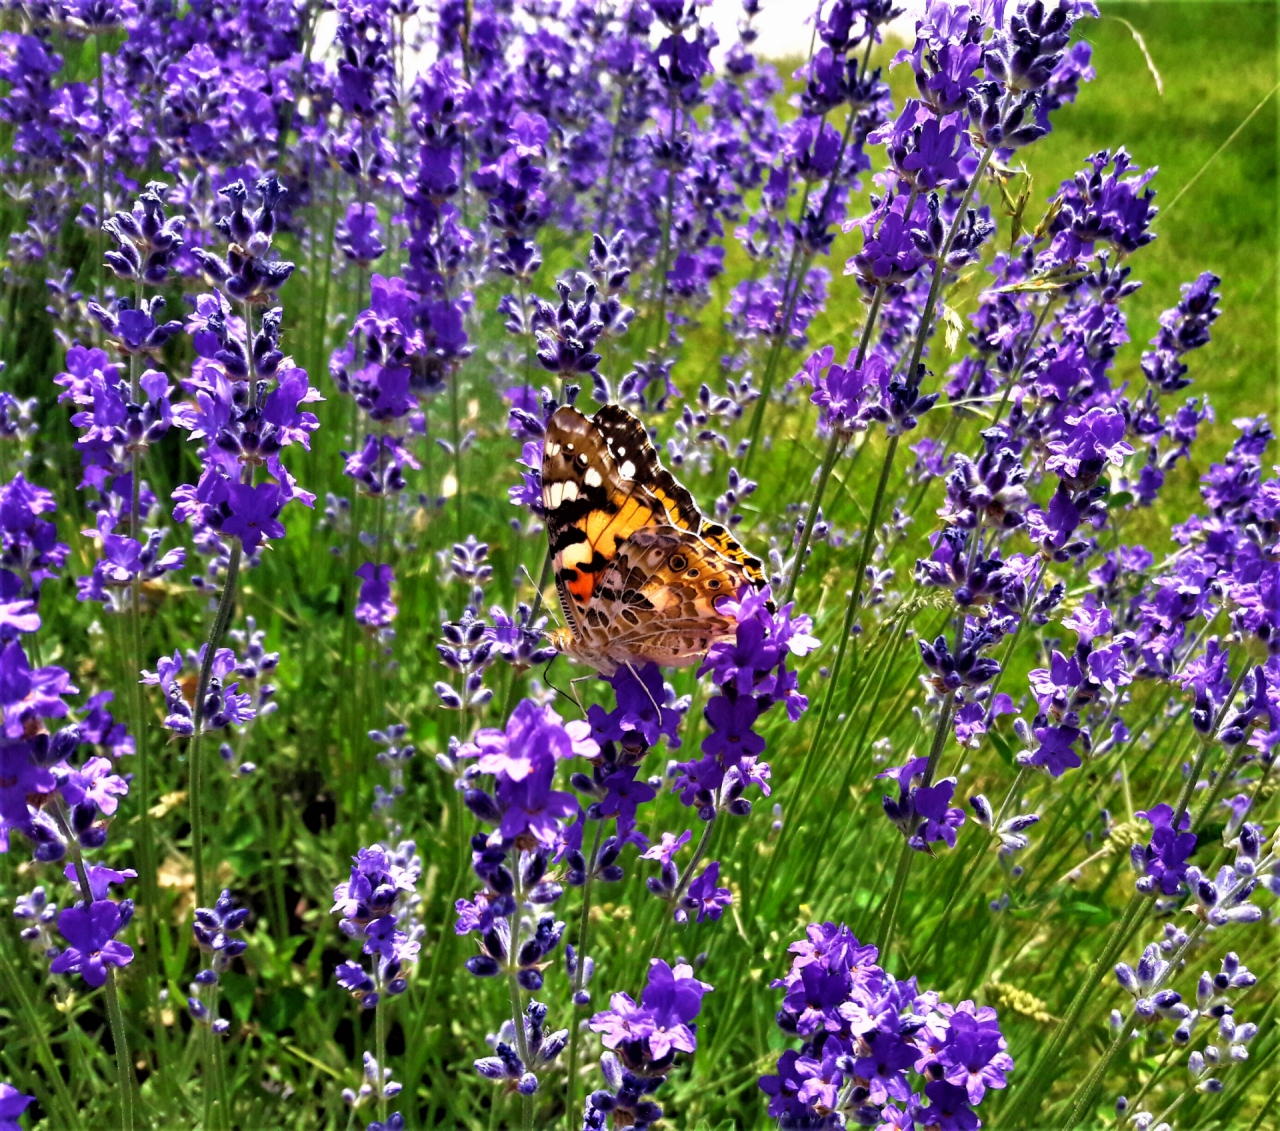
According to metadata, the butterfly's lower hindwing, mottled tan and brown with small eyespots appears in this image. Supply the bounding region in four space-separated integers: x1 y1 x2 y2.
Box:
584 526 750 667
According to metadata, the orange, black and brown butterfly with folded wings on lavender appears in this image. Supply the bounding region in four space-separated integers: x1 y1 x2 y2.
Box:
543 404 764 676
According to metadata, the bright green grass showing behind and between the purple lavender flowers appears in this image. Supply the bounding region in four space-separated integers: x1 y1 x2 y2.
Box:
0 3 1280 1131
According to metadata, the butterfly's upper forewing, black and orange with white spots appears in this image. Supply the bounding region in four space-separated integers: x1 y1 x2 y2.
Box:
543 404 703 632
